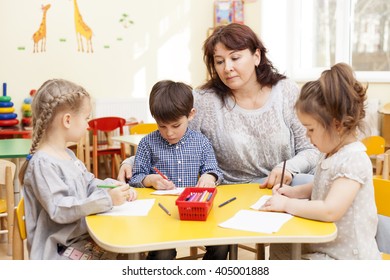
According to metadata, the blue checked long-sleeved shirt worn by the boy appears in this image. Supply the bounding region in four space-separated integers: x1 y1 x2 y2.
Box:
129 129 223 187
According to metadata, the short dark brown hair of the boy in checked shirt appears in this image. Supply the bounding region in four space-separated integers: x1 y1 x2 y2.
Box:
149 80 194 123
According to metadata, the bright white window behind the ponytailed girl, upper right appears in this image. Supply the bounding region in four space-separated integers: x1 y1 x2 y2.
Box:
262 0 390 82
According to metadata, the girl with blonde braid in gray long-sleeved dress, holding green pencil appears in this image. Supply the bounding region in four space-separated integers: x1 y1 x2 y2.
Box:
19 79 137 260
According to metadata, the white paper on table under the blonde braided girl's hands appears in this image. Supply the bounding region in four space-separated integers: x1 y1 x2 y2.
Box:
97 199 155 216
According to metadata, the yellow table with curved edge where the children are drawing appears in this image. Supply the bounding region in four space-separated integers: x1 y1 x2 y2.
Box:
86 184 337 259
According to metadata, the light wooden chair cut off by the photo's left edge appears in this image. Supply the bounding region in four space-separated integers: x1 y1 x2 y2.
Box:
0 159 16 256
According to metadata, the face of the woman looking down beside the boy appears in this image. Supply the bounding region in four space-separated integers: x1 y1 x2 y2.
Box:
214 43 260 90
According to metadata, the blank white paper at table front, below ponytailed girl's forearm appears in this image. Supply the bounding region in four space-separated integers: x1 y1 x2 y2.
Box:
219 210 293 233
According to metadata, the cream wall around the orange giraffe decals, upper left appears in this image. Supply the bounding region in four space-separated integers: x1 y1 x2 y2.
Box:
0 0 213 122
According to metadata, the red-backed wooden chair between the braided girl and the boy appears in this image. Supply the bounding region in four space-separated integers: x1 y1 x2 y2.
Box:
88 117 126 178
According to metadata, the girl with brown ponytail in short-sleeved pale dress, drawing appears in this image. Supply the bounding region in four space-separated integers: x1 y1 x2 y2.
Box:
263 63 381 260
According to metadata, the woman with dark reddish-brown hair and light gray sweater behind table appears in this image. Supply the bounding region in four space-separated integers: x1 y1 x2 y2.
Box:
119 23 318 188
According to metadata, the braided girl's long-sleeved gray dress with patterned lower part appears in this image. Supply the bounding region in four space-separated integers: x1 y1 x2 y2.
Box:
23 150 115 260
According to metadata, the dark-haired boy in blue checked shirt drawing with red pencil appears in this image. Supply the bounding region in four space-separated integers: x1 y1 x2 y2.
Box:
129 80 228 260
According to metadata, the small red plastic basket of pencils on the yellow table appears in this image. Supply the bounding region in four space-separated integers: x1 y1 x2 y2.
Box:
176 188 217 221
